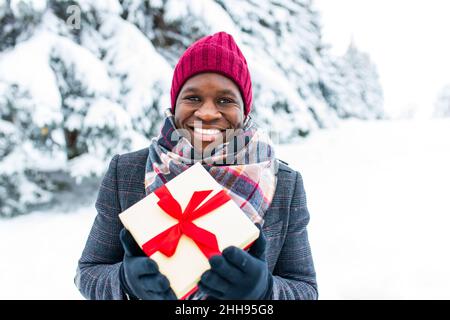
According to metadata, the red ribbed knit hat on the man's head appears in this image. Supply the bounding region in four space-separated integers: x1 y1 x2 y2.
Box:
170 32 253 115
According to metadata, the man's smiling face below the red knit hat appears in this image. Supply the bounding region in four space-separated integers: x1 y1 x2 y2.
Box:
175 72 244 151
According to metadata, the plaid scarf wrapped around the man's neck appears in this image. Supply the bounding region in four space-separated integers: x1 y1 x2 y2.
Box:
144 109 278 228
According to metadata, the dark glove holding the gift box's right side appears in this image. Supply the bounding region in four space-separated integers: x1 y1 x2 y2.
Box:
198 228 273 300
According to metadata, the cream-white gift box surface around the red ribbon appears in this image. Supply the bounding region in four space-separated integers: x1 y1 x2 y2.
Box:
119 162 259 299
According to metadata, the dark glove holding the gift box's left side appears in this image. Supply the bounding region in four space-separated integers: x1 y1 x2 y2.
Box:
119 228 177 300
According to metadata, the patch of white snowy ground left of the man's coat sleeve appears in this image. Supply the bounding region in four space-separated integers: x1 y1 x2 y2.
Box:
0 208 94 299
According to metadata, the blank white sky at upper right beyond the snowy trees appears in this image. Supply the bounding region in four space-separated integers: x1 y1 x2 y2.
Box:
314 0 450 116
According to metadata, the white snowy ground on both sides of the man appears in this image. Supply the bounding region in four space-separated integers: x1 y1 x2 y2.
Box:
0 120 450 299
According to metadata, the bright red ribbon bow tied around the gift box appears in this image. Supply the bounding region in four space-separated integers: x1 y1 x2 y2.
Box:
142 185 231 259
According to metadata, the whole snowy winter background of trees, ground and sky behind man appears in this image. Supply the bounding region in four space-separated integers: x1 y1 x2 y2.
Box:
0 0 450 299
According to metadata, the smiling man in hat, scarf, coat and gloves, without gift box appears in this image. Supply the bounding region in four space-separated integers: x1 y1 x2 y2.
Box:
75 32 317 299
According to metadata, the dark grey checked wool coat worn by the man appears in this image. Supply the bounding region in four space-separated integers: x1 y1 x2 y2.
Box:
75 149 318 300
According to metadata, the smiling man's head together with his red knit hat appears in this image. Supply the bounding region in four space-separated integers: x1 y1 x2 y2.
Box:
171 32 253 158
